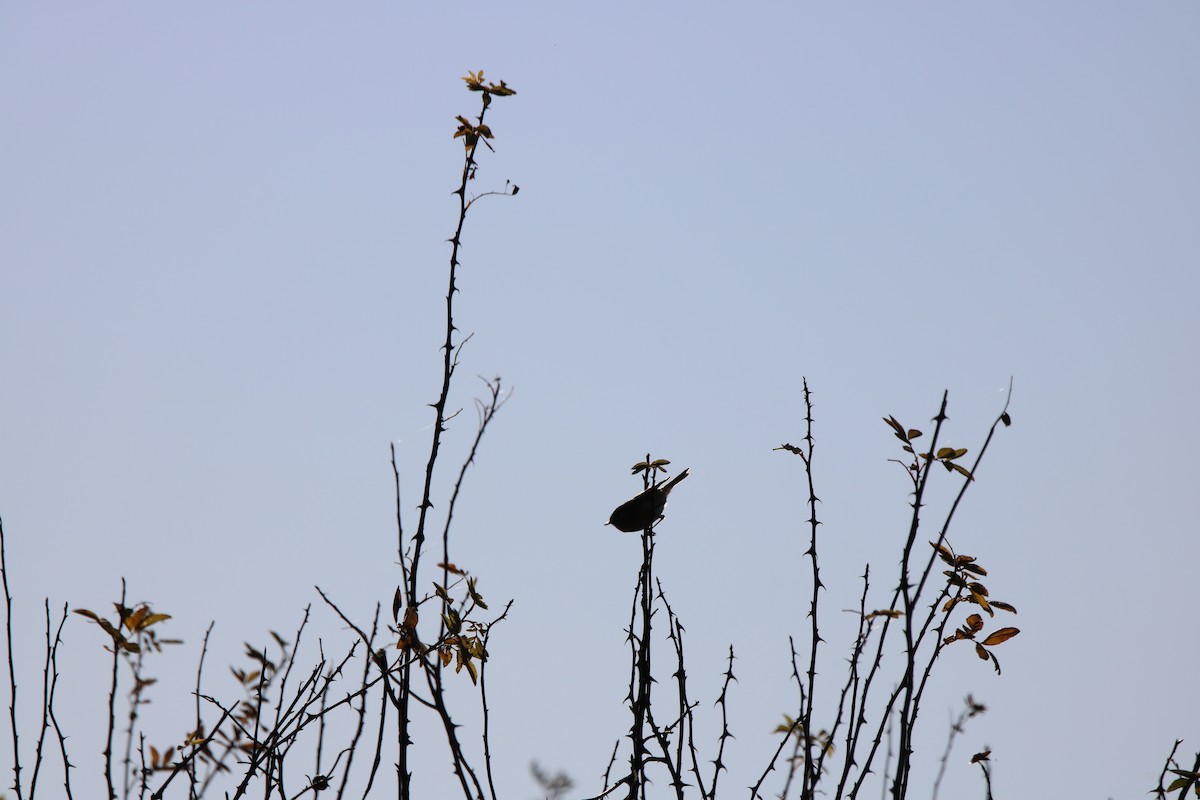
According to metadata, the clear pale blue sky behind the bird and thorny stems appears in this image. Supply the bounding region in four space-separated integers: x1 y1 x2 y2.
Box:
0 1 1200 799
